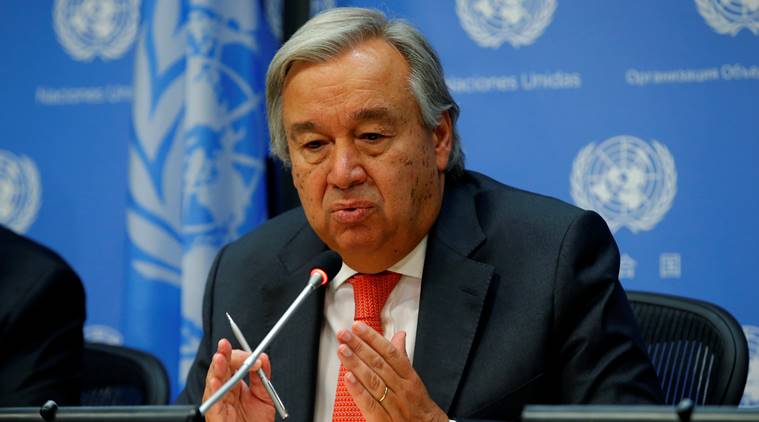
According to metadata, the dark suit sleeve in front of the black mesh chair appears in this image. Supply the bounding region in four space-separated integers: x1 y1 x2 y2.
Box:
554 212 662 404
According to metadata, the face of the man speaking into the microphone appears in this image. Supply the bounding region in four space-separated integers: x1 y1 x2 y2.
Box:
282 39 451 273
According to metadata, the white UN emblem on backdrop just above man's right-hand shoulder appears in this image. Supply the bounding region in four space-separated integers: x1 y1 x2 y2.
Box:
570 135 677 233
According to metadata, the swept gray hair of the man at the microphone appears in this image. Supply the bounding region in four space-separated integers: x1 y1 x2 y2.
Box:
266 7 464 176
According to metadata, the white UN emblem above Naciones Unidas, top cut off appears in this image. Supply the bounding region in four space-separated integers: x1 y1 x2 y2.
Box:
456 0 556 48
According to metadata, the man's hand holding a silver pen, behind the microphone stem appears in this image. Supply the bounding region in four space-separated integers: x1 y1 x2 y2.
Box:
203 339 274 422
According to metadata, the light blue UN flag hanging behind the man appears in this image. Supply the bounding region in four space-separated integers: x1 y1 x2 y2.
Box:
124 0 279 397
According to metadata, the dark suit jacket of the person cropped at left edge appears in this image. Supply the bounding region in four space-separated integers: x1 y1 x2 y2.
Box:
0 226 85 406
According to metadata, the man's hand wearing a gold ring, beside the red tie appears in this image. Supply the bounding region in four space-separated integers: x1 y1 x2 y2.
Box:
337 322 448 422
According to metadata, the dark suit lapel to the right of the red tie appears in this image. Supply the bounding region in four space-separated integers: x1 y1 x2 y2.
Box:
414 177 494 412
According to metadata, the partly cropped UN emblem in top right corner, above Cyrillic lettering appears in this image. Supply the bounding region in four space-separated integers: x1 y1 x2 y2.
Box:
696 0 759 36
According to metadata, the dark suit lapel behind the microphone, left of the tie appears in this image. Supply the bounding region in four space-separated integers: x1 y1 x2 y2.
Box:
261 221 325 422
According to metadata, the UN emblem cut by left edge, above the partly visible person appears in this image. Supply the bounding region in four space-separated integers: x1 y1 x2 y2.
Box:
0 149 42 233
